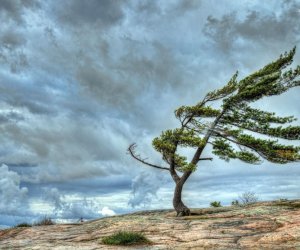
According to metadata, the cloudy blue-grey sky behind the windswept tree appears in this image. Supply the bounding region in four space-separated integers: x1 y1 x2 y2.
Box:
0 0 300 227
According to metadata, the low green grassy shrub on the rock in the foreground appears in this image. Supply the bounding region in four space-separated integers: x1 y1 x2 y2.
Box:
102 231 150 245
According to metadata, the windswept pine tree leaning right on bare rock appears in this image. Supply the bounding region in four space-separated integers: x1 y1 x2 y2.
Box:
128 48 300 216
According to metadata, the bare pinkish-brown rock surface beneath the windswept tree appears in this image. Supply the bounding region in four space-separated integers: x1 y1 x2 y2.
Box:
0 200 300 250
